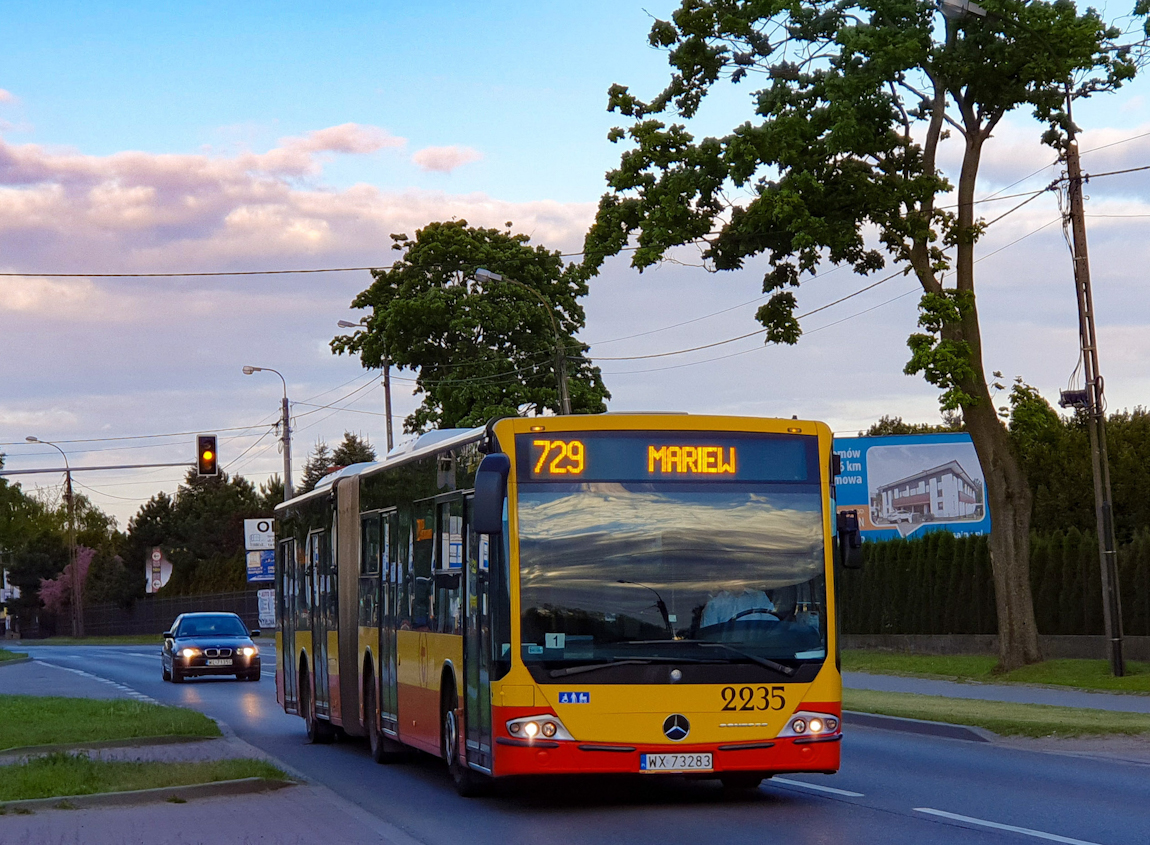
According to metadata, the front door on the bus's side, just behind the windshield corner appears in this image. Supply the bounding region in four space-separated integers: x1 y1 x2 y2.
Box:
463 498 491 773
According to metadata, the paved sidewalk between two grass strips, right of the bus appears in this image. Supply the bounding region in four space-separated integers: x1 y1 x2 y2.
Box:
843 671 1150 713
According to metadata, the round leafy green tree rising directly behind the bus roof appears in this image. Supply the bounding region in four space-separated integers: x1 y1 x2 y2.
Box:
331 221 611 431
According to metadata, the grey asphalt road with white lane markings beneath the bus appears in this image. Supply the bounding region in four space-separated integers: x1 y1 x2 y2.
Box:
11 644 1150 845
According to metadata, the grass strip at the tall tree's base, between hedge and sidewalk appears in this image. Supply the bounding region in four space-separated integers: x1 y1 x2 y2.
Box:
843 651 1150 693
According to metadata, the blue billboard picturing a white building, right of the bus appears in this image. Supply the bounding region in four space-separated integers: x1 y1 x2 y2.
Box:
834 433 990 540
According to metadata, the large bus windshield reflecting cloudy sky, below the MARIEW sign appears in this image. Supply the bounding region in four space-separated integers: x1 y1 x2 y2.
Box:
519 483 827 679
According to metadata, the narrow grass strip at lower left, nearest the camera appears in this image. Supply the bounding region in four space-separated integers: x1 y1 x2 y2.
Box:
0 754 286 801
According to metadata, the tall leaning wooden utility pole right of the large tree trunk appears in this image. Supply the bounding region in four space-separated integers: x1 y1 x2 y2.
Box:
1060 128 1126 677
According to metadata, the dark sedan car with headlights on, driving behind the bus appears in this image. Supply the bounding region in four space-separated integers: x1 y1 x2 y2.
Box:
160 613 260 684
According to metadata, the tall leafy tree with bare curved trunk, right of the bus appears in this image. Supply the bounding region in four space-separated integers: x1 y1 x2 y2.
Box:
584 0 1150 669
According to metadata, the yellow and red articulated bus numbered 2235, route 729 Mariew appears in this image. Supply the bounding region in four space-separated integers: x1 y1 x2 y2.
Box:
276 414 860 794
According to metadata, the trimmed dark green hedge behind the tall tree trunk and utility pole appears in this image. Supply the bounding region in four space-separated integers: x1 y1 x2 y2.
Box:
838 528 1150 636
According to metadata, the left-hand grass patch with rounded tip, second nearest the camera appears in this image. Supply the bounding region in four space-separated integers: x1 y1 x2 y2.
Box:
0 696 220 749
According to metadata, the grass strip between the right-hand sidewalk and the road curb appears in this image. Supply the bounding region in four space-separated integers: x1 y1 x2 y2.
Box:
843 690 1150 737
